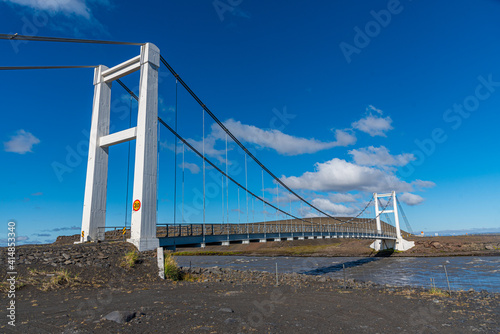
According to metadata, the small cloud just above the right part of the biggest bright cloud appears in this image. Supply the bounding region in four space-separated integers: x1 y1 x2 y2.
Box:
349 146 415 167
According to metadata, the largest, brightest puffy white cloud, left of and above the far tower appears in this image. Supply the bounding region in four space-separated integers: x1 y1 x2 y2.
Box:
281 158 412 192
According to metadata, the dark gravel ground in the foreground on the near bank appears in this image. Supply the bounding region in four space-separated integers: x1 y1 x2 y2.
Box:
0 243 500 333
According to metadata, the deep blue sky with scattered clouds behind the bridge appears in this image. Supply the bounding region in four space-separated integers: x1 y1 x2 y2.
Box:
0 0 500 243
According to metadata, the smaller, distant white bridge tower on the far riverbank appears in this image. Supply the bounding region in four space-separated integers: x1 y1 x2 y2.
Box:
370 191 415 251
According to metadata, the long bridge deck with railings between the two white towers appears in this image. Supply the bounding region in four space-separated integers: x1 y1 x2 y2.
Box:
157 224 396 248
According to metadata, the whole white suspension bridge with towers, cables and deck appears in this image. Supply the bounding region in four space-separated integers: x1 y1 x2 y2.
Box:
0 34 414 251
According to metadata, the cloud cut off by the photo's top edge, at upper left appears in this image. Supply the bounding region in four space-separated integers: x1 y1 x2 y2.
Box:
4 0 91 19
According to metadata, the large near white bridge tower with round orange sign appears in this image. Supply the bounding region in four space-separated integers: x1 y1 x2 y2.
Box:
80 43 160 251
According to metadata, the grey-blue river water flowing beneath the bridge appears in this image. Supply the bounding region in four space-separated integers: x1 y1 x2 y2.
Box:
177 256 500 292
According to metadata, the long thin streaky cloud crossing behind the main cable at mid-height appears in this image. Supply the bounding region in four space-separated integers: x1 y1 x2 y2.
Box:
212 119 356 155
